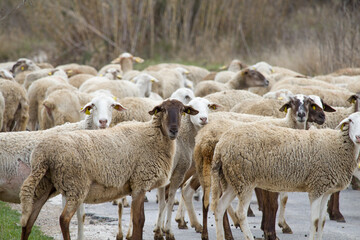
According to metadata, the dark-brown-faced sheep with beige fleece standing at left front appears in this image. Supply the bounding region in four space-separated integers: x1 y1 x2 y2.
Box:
20 100 198 240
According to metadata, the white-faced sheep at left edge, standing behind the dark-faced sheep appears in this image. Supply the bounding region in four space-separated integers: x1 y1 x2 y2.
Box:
0 93 125 240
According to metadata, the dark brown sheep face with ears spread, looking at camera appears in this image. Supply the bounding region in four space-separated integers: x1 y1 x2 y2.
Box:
149 99 198 140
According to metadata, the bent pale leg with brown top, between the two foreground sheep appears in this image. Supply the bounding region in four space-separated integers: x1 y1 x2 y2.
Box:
183 177 203 233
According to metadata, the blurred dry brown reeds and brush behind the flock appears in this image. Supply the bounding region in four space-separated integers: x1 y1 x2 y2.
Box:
0 0 360 75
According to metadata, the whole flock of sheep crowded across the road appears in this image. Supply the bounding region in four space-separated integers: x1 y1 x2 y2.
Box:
0 53 360 240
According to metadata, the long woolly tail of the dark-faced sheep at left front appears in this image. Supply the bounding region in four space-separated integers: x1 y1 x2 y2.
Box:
20 158 48 227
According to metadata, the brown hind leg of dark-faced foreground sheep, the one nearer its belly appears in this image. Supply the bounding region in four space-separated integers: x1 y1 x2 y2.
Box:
60 199 81 240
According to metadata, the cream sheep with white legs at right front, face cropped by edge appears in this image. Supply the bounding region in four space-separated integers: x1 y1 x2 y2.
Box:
211 113 360 239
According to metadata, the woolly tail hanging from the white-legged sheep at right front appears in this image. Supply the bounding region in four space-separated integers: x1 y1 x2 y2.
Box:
210 152 224 212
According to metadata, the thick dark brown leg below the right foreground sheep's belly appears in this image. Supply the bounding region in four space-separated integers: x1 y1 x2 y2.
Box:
259 189 279 240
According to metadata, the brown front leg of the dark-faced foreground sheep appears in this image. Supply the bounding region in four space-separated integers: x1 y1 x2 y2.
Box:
131 191 145 240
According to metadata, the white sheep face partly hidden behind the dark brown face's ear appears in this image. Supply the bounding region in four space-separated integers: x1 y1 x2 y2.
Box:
189 97 219 128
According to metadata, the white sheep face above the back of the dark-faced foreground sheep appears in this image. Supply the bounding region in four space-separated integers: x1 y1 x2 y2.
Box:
81 96 126 129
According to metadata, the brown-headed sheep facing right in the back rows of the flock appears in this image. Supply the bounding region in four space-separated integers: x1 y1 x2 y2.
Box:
194 68 269 97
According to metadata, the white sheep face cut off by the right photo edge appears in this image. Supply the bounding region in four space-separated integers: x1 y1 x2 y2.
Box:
336 112 360 144
